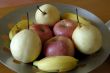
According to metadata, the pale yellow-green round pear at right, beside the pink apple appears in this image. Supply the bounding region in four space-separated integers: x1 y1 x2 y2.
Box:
72 24 102 55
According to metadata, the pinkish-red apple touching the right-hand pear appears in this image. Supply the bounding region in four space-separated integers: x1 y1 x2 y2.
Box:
53 19 77 38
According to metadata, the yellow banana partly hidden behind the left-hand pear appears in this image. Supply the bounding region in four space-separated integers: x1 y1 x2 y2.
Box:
9 19 32 40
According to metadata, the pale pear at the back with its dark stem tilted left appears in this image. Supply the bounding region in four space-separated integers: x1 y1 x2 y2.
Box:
35 4 60 26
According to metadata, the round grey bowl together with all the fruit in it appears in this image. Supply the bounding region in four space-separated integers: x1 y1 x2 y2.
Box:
0 3 110 73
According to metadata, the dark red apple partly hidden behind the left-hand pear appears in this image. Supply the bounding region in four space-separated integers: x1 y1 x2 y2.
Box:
30 24 53 43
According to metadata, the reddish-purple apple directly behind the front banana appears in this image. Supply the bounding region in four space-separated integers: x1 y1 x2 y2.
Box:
43 36 75 56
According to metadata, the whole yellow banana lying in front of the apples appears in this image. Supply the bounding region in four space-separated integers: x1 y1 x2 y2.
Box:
33 56 78 72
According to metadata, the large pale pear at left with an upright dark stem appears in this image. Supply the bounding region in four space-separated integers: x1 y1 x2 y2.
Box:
10 29 42 63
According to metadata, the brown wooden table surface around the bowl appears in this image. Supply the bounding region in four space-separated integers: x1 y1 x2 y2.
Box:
0 0 110 73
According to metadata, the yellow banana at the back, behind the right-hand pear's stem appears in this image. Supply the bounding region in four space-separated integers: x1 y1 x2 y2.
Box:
62 13 91 24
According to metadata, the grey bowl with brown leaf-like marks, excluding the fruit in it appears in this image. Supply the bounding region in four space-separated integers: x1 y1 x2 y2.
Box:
0 3 110 73
